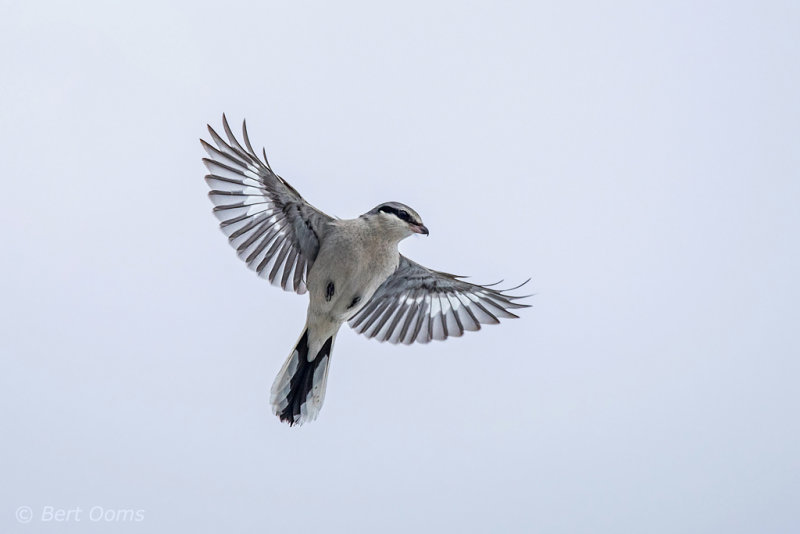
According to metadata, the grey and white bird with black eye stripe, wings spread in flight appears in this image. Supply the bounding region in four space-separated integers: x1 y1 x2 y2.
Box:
200 114 530 426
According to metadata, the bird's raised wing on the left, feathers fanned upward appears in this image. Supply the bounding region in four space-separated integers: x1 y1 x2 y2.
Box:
206 115 333 294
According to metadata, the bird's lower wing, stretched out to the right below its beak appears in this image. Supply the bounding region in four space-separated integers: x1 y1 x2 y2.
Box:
349 255 528 345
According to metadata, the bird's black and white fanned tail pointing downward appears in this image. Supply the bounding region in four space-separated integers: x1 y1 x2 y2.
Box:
270 328 336 426
